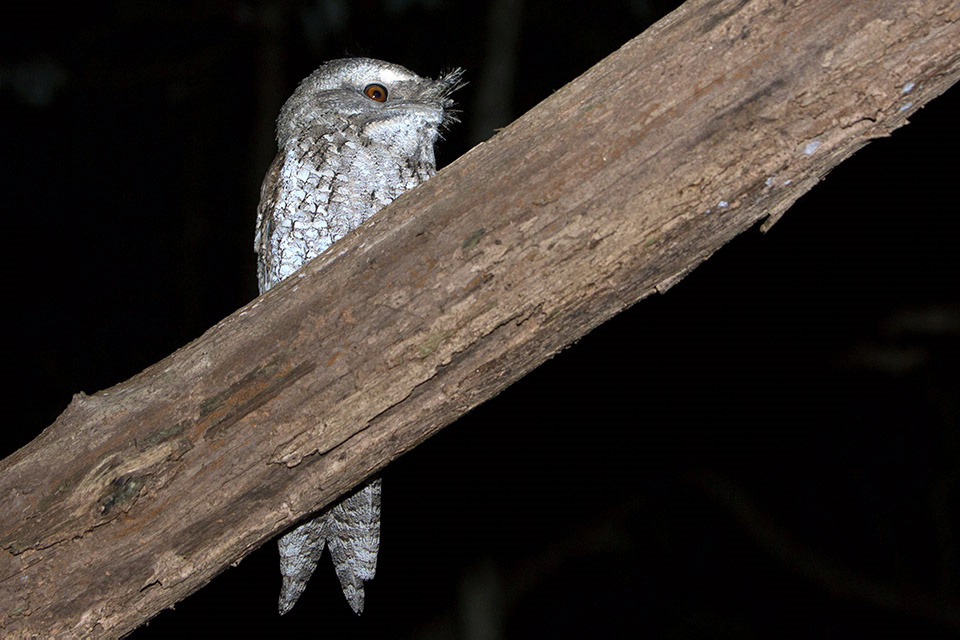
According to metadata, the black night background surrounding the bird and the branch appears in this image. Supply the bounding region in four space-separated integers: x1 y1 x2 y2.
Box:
0 0 960 638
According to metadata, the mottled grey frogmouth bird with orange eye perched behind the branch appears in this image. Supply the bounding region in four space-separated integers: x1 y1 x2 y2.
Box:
254 58 461 614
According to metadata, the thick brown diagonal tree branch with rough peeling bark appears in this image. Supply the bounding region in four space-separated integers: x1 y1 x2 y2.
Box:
0 0 960 637
